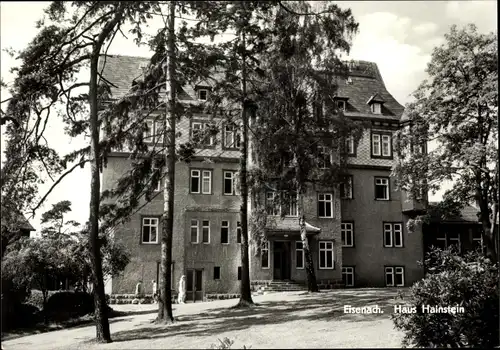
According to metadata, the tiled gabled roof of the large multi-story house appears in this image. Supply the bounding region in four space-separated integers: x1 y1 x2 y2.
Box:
99 55 404 120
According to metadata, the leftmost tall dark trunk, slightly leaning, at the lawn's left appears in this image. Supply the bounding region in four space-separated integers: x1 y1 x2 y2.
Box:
89 51 111 343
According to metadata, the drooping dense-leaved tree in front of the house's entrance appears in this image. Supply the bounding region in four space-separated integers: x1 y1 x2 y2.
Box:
252 2 362 291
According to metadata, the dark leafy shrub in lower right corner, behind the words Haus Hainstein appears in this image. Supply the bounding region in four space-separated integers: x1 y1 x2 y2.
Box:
391 249 499 347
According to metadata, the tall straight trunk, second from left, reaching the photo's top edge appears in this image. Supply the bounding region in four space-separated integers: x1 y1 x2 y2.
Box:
157 1 176 323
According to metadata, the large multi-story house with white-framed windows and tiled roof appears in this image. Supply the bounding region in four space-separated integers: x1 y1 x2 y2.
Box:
102 56 423 300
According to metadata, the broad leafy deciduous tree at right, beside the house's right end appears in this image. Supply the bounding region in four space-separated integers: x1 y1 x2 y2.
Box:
394 24 499 260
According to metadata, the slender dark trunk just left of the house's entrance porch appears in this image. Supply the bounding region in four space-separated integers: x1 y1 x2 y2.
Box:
237 33 253 307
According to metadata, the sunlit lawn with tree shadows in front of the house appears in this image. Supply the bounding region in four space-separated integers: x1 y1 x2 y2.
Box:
2 289 403 350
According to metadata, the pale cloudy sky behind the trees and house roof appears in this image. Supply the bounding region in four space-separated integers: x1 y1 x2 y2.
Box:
0 1 497 229
